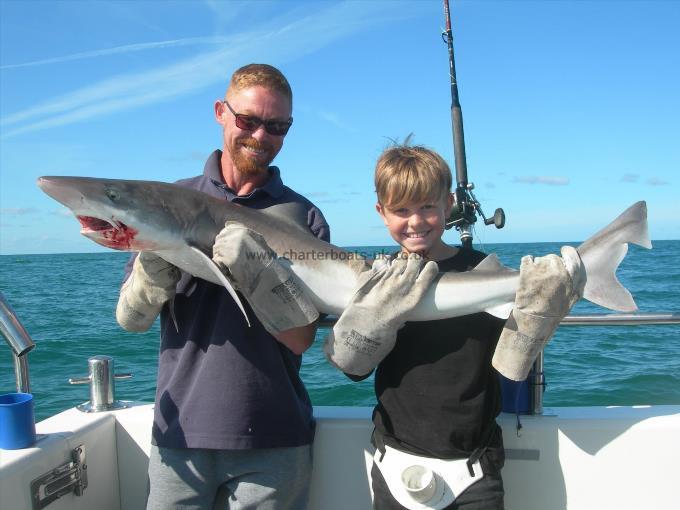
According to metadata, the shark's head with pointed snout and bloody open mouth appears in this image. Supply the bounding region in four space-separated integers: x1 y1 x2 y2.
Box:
38 176 205 251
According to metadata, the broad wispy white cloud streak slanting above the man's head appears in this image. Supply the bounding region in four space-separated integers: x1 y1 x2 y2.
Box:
0 2 417 138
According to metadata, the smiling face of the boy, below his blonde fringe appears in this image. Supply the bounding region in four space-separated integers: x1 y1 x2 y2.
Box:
375 194 453 260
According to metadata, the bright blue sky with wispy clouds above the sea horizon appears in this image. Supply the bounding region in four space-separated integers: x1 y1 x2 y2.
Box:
0 0 680 254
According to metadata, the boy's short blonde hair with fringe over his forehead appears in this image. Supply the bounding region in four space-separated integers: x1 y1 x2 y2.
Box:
375 144 453 209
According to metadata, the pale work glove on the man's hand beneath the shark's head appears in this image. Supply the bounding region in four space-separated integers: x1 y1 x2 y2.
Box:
116 252 181 331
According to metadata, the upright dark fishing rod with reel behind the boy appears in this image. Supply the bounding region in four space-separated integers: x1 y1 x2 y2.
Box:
442 0 505 248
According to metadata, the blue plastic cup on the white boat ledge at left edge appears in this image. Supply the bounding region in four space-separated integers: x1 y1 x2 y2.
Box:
0 393 35 450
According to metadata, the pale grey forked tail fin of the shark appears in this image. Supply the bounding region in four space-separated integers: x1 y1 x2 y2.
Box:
576 201 652 312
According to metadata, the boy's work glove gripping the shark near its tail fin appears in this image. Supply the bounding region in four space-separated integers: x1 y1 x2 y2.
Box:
491 246 586 381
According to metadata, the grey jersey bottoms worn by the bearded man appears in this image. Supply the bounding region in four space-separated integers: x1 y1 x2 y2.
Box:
146 445 312 510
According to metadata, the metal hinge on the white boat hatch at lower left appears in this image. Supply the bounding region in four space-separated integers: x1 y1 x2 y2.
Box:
31 444 87 510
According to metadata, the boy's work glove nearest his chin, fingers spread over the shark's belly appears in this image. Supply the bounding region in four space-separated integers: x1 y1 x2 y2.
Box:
324 254 439 376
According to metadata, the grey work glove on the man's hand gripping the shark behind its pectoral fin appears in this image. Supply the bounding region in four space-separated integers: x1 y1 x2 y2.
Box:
213 221 319 335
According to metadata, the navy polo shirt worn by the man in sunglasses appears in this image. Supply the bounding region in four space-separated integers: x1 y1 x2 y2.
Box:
128 151 329 450
